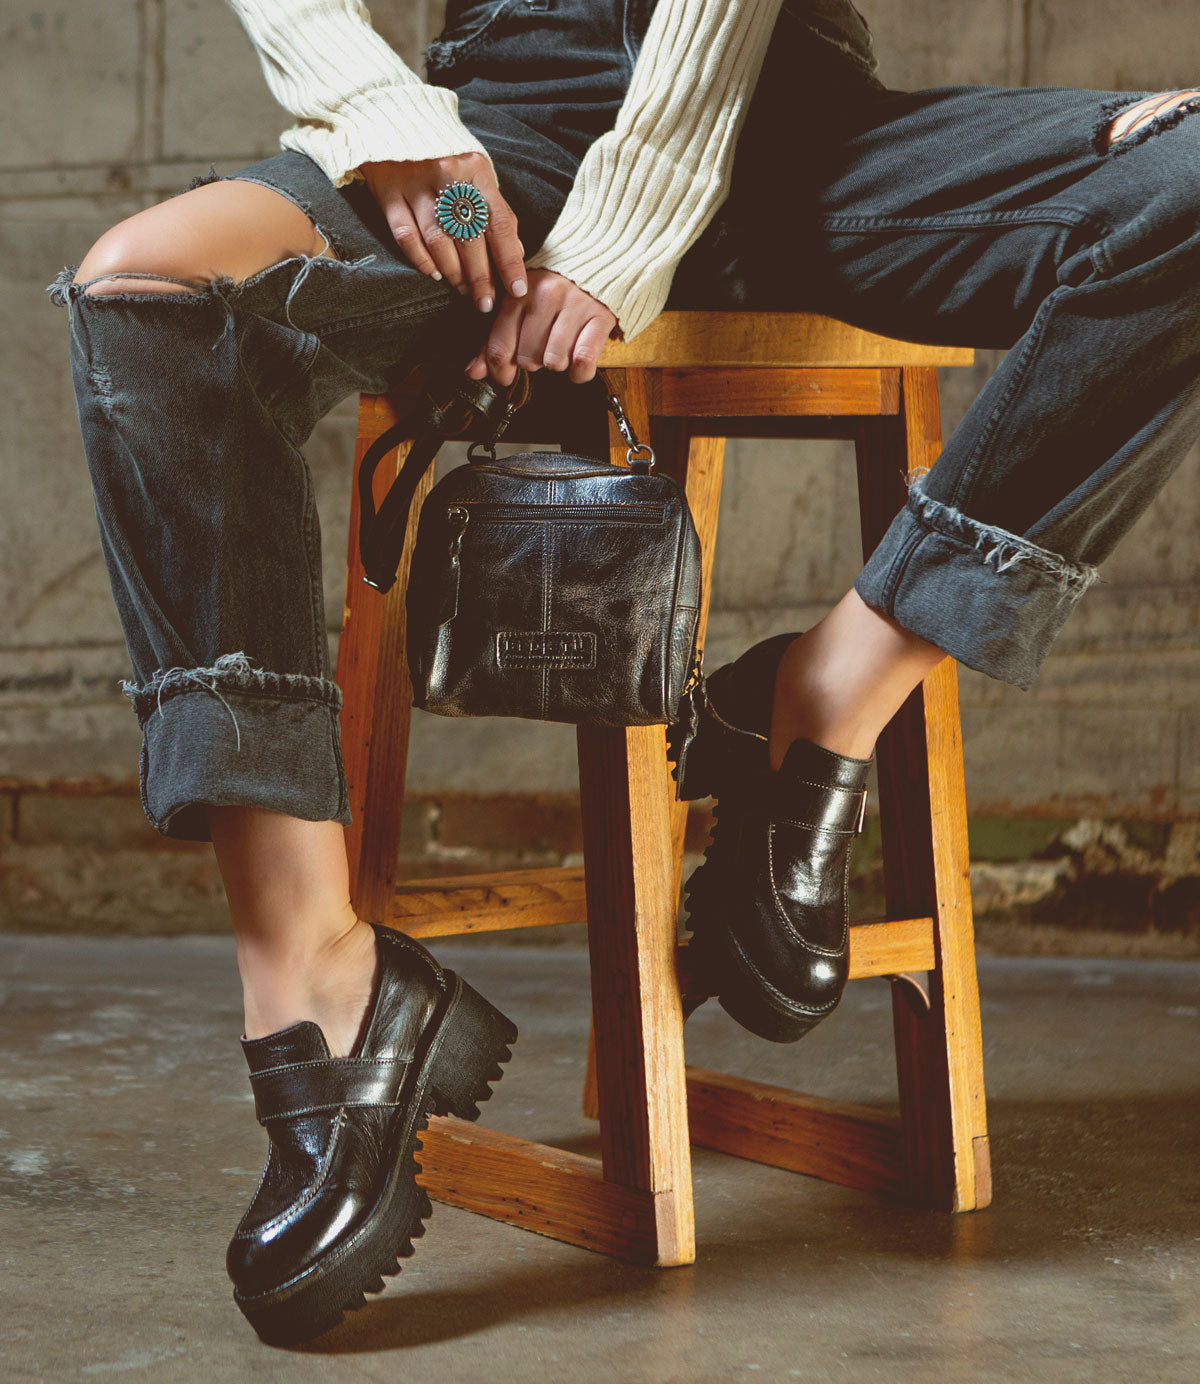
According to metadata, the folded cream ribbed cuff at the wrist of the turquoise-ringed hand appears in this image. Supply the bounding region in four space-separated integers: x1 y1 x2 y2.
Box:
280 82 496 187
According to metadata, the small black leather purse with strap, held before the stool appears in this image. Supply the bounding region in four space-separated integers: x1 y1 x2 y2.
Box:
358 375 700 725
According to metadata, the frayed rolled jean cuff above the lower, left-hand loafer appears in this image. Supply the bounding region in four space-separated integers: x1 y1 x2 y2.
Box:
122 653 350 841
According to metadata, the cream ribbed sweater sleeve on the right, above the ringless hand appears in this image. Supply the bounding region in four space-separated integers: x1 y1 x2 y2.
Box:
529 0 782 339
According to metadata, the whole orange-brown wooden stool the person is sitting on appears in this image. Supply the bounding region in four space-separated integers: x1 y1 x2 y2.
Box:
338 311 991 1265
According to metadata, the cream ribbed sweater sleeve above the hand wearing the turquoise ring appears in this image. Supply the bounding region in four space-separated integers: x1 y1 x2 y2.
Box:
228 0 491 187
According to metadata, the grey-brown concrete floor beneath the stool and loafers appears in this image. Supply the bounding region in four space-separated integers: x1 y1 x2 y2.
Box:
0 937 1200 1384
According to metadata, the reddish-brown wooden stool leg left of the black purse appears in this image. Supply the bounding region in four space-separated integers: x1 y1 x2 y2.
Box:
336 394 433 923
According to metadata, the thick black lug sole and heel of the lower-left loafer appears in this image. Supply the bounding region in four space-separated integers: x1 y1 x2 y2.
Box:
234 970 516 1345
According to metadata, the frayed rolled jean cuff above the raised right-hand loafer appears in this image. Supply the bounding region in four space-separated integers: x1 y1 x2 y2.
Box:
854 480 1099 689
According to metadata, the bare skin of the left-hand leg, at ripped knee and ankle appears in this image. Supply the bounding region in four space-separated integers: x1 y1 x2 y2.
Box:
75 179 365 1056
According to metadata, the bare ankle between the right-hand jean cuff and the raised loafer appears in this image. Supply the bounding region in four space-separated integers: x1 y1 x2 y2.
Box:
770 590 945 770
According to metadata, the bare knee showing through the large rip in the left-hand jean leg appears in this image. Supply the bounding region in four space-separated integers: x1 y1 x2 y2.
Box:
75 179 332 295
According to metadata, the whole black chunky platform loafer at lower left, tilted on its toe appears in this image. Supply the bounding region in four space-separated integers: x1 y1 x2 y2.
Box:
226 925 516 1345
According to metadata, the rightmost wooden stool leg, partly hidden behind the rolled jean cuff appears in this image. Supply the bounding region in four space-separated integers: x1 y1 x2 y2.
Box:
858 368 991 1211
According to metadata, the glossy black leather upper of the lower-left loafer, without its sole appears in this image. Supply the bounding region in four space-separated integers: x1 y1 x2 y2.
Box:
226 927 447 1298
